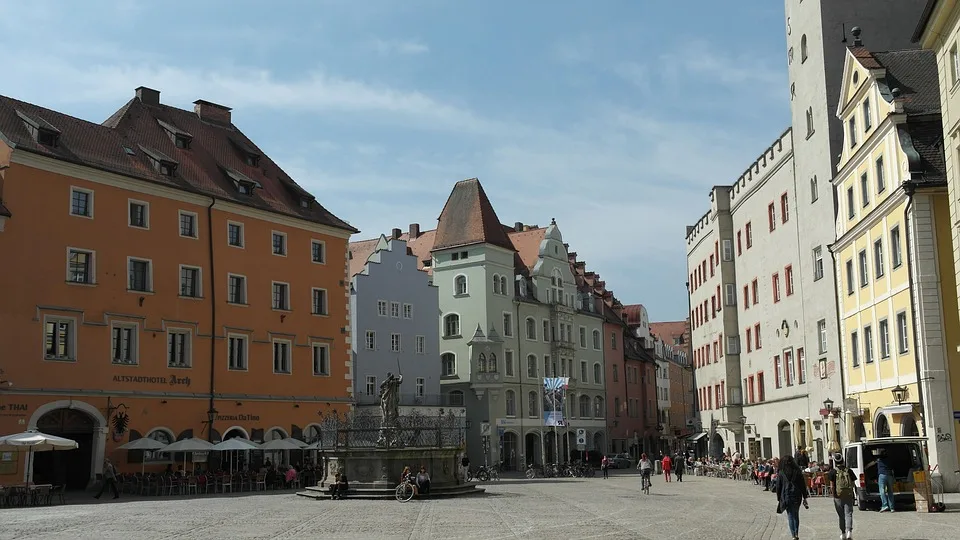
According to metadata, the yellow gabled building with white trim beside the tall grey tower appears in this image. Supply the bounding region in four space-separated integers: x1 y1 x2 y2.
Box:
831 40 960 480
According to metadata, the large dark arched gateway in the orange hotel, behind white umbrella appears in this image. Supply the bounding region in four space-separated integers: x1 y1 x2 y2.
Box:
33 409 96 489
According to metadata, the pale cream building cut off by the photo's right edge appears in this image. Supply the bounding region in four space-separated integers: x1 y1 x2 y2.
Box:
913 0 960 494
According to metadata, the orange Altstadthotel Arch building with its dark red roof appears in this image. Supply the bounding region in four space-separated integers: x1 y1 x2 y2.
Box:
0 87 357 488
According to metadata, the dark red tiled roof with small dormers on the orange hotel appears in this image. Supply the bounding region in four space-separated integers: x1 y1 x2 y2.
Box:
0 91 357 233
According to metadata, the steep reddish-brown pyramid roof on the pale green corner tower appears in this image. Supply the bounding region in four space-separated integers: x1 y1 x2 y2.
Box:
433 178 514 251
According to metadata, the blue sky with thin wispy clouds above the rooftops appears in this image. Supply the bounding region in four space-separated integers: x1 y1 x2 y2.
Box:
0 0 789 320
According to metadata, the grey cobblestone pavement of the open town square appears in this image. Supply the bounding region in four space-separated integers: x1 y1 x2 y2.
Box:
0 471 960 540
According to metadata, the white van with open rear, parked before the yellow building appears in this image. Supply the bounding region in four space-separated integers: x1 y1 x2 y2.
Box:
843 437 928 510
